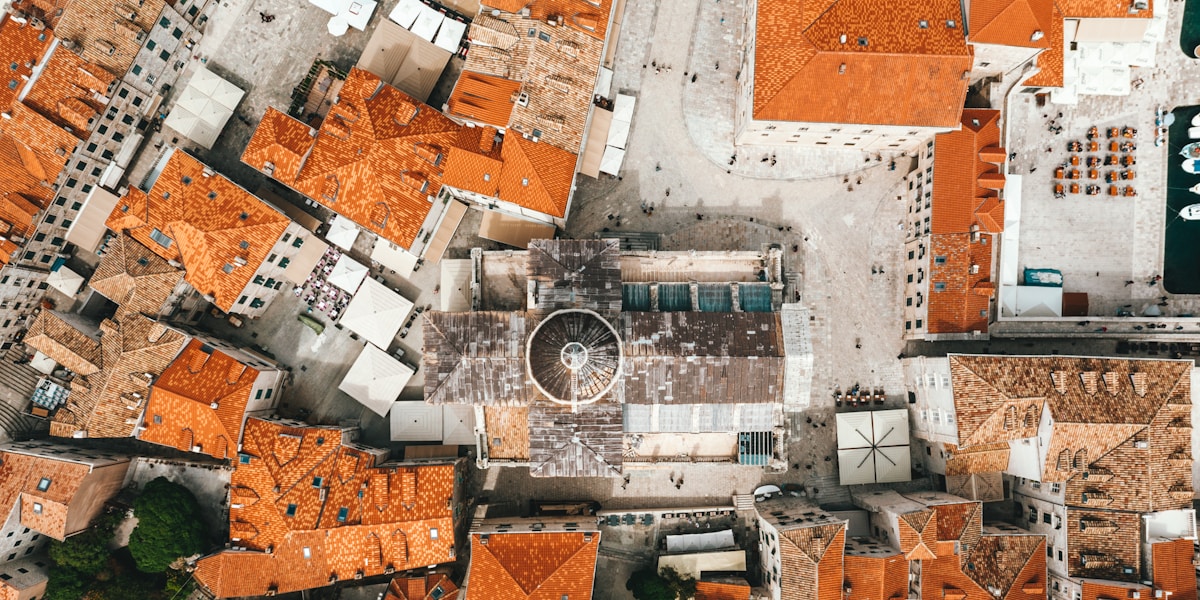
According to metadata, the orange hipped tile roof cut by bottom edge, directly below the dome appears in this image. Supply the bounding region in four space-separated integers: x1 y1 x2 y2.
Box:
467 532 600 600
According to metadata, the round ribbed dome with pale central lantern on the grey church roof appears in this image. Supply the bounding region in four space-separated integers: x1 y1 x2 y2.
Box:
526 308 623 404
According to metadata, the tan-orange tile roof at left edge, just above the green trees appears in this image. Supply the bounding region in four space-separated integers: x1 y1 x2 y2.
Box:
0 451 91 540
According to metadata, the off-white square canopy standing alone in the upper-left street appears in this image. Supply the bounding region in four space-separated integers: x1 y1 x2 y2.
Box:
163 66 246 149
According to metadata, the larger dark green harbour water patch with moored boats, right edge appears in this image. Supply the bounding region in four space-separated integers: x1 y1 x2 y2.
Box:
1163 108 1200 294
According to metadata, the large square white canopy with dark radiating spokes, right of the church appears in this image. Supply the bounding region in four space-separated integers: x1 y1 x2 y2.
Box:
836 409 912 485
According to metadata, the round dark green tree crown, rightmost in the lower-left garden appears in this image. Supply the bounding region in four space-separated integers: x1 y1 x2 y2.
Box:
130 478 204 572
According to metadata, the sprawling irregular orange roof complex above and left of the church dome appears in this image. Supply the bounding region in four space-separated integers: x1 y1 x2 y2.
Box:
242 68 577 248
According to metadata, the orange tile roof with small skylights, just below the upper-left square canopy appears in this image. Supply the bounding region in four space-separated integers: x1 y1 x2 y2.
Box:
106 150 290 312
